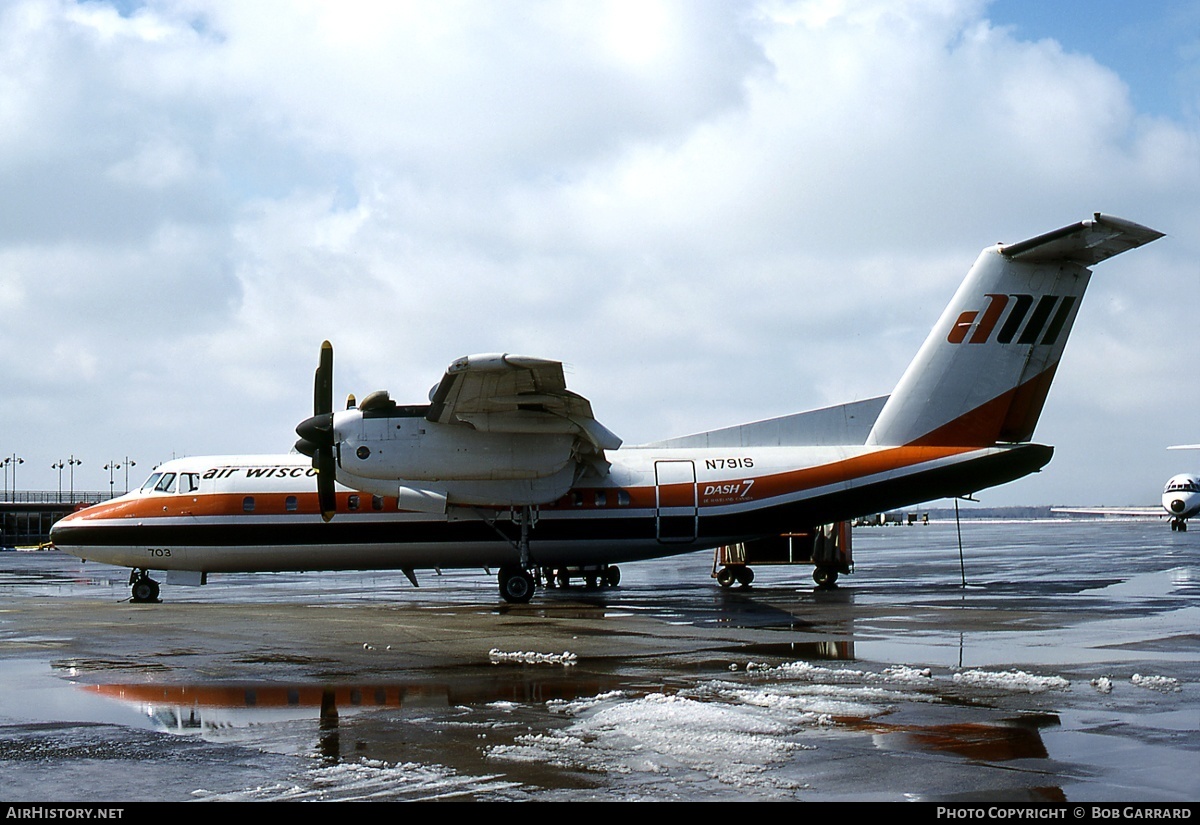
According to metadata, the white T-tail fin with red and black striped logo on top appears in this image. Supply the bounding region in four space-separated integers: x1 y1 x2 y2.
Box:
866 212 1163 446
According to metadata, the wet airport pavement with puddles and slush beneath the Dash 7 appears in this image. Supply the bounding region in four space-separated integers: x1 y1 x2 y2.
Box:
0 520 1200 802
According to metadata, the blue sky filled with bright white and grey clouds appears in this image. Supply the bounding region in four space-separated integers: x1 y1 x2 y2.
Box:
0 0 1200 506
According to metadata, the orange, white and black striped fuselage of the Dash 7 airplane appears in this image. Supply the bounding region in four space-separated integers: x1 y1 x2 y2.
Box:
52 445 1051 572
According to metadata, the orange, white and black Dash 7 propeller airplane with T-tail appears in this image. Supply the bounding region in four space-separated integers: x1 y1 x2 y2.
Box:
50 212 1163 603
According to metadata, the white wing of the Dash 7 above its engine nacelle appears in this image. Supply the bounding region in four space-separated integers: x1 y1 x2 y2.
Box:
425 353 620 453
